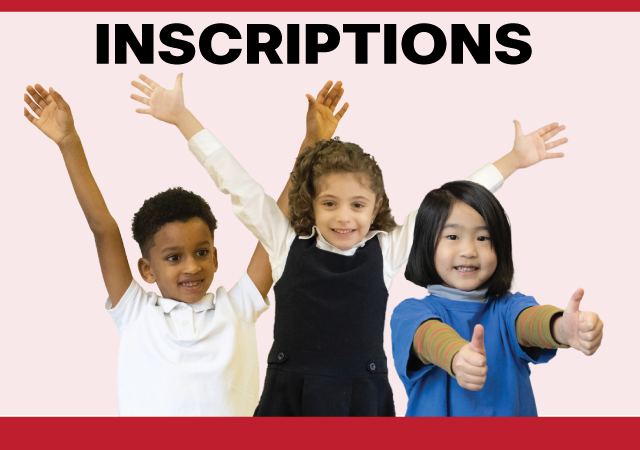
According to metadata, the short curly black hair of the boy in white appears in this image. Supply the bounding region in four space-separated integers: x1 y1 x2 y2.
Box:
131 187 218 258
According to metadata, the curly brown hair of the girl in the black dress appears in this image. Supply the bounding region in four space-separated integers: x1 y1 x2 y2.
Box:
289 137 398 236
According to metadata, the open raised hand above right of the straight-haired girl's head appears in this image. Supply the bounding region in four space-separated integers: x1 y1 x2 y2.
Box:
512 120 569 169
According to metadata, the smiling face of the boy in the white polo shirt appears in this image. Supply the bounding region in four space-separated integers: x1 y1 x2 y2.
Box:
138 217 218 303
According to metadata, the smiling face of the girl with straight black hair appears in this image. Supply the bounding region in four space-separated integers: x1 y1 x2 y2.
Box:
434 202 498 291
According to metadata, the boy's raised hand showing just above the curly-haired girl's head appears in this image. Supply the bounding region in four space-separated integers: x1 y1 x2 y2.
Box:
305 81 349 145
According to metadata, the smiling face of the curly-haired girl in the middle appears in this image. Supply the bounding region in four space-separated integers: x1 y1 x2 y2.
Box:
313 173 380 250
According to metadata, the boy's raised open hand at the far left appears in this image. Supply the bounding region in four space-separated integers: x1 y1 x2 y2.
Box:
24 84 77 145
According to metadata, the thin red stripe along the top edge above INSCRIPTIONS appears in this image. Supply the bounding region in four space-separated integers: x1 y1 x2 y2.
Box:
0 0 640 11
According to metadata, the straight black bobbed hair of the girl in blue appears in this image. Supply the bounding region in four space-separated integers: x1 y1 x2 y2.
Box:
404 181 514 296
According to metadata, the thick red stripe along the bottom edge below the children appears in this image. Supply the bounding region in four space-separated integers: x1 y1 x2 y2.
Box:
0 417 640 450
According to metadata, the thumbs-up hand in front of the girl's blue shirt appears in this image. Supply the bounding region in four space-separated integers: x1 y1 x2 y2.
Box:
451 325 488 391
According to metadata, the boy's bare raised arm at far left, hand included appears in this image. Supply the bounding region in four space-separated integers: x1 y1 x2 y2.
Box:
24 84 133 307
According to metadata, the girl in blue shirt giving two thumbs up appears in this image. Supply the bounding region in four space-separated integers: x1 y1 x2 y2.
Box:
391 181 603 416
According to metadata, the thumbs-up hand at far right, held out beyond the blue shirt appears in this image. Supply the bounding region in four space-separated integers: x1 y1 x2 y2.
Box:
552 289 604 356
